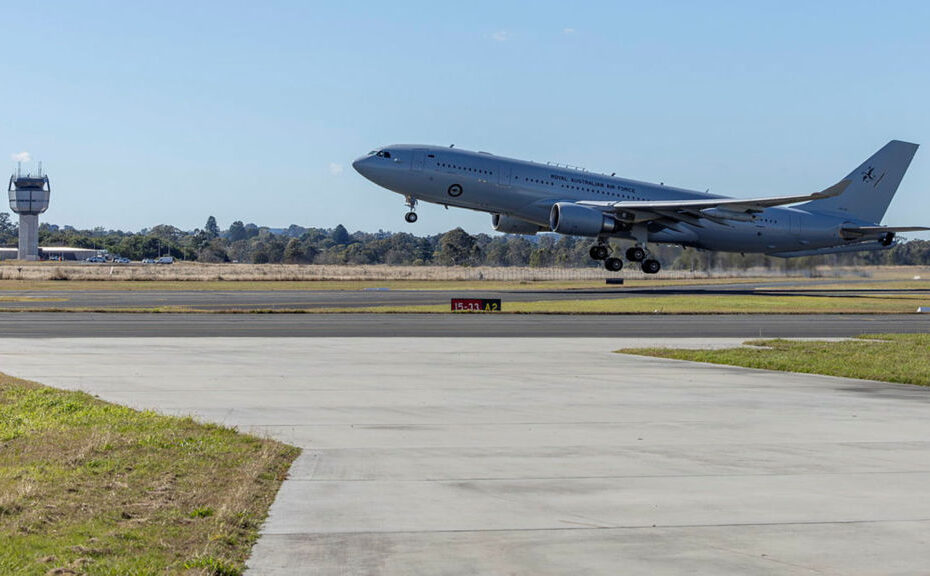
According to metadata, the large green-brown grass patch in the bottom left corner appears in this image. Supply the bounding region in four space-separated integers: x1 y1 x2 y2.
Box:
0 375 298 576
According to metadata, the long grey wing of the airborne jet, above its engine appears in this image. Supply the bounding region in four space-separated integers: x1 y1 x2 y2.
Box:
577 179 851 226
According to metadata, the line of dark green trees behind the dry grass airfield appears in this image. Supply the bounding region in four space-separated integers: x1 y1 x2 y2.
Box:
0 213 930 271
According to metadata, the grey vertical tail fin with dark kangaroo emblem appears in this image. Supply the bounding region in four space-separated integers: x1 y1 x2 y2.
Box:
799 140 917 224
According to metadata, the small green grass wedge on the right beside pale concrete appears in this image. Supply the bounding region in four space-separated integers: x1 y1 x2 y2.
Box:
618 334 930 386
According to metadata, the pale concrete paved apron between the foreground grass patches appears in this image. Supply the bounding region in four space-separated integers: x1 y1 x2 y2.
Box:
0 338 930 576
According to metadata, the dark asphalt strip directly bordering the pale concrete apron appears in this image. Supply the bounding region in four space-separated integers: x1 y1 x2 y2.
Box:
0 312 930 338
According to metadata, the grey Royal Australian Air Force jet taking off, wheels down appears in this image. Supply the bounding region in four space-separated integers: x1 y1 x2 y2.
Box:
352 140 930 274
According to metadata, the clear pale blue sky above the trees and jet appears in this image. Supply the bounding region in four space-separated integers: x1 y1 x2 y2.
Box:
0 1 930 237
